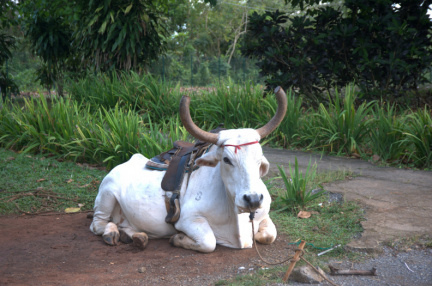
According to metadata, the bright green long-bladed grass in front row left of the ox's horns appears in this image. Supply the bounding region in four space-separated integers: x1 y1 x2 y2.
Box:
0 95 188 168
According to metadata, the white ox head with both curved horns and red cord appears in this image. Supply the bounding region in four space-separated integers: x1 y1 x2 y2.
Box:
180 87 287 213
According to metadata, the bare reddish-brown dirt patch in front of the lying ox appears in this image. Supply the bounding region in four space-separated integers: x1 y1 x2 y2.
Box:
0 214 292 285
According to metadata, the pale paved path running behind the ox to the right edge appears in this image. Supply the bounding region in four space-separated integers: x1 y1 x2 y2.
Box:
264 147 432 252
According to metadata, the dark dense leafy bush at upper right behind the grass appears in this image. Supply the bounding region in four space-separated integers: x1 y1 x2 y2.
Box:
242 0 432 101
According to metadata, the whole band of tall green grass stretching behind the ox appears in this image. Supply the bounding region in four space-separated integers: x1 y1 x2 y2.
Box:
0 72 432 168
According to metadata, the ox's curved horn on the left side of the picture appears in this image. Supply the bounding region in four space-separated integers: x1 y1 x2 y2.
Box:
180 96 219 144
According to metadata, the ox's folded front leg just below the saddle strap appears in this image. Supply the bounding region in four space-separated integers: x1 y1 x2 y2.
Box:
170 220 216 252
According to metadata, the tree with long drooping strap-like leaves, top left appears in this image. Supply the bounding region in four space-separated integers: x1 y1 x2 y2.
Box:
74 0 168 71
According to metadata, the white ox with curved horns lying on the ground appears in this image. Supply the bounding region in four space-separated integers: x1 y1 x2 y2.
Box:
90 87 287 252
